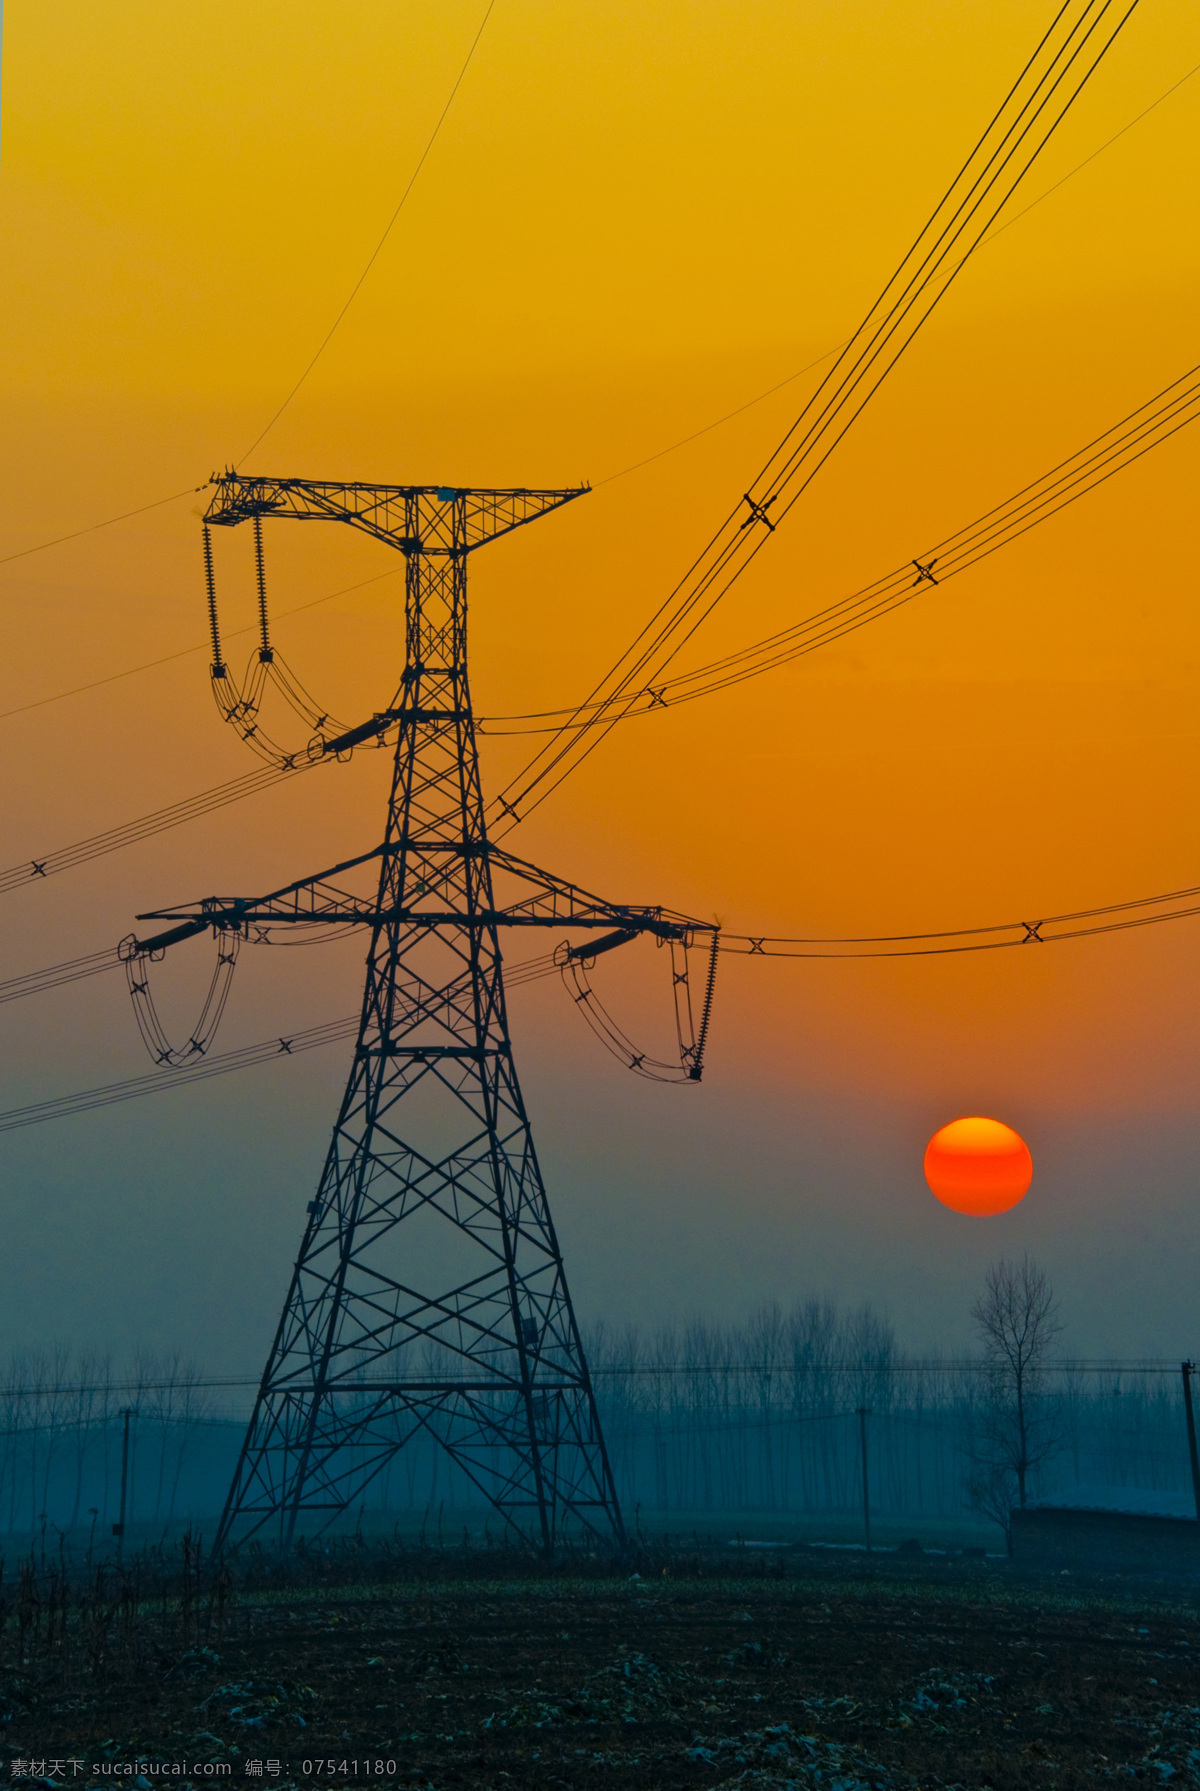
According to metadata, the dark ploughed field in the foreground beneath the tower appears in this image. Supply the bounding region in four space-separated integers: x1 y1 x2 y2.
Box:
0 1551 1200 1791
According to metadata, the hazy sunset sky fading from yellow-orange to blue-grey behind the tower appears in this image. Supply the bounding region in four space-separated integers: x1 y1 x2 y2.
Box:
0 0 1200 1370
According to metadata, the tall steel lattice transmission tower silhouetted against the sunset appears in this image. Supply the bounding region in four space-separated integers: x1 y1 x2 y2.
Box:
131 473 715 1553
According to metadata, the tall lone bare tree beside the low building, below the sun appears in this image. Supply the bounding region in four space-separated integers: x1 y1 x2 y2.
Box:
967 1254 1062 1546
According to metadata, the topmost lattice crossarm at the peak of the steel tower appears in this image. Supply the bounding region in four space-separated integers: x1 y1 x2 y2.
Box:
204 471 591 555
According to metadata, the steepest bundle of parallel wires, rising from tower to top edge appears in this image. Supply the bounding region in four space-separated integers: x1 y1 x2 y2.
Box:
493 0 1137 831
